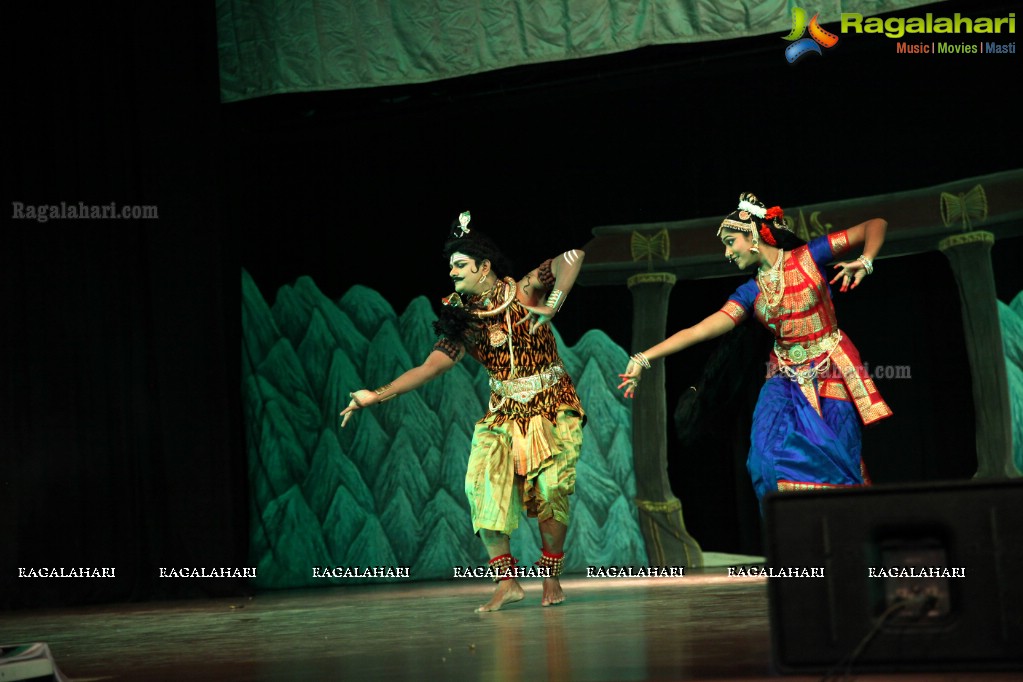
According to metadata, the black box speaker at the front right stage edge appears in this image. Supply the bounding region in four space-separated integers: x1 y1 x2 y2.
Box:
764 480 1023 675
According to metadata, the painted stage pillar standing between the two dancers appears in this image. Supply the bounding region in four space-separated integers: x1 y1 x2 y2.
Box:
628 272 703 567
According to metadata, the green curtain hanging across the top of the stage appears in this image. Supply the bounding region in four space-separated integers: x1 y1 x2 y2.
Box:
217 0 936 102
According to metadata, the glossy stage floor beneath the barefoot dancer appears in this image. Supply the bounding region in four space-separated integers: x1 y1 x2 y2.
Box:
0 569 1021 682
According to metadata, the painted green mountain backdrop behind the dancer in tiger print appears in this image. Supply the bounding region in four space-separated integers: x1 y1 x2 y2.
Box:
241 271 647 588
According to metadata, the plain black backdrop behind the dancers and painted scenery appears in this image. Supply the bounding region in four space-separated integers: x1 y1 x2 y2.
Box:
0 2 1023 606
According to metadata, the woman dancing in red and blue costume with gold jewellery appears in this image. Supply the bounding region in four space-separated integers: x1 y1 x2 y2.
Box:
618 193 891 512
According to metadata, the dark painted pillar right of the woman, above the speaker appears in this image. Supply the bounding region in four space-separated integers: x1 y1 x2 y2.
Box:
938 230 1020 479
